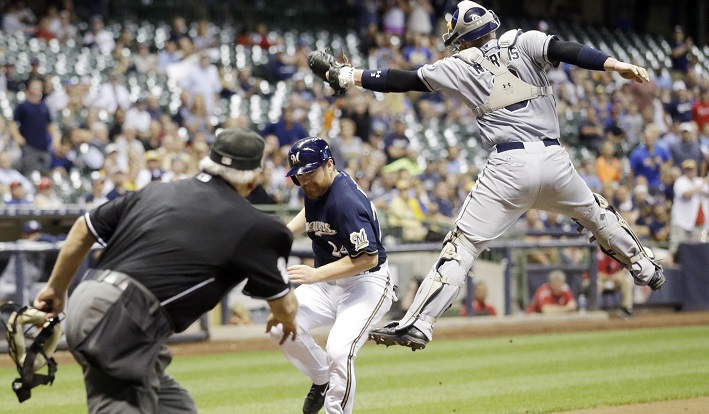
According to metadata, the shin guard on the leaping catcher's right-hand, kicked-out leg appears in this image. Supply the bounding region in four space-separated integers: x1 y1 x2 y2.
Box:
579 193 665 290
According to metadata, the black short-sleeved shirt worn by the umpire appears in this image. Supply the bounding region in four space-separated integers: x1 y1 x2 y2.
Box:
85 173 293 332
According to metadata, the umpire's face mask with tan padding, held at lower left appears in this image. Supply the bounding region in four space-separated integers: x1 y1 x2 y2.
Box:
0 302 62 402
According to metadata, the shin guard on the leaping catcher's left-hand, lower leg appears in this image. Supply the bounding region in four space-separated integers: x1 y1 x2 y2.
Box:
398 229 474 339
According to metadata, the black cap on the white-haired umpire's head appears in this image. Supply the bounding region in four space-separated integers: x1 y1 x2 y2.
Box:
209 128 266 171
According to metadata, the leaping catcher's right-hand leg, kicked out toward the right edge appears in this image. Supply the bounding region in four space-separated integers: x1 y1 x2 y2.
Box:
534 148 665 290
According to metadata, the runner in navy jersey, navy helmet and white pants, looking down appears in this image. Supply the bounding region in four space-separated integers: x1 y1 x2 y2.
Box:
271 137 394 414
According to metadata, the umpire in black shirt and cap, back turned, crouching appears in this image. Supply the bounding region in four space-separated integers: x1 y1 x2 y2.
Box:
34 128 298 414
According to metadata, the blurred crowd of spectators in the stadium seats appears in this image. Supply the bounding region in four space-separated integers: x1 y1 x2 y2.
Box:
0 0 709 258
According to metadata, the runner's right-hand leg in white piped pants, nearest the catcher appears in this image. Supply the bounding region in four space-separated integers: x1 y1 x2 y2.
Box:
325 274 392 414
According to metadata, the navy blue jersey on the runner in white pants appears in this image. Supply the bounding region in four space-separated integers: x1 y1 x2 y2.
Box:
305 170 386 267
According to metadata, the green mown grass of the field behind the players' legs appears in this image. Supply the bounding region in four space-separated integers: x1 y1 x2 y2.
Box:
0 326 709 414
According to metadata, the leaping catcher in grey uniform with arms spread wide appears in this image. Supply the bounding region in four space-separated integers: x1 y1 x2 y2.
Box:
309 1 665 350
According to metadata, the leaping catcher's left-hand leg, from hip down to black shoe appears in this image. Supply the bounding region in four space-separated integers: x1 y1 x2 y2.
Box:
370 151 539 350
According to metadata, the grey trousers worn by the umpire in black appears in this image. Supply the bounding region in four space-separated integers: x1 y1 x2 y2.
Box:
66 280 197 414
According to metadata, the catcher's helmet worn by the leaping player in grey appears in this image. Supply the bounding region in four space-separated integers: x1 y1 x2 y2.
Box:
443 0 500 46
